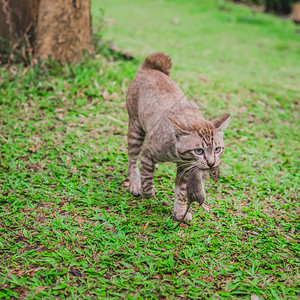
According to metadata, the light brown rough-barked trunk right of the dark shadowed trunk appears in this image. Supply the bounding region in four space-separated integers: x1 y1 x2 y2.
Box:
34 0 94 63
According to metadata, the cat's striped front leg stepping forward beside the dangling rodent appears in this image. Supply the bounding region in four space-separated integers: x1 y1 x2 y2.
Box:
174 166 192 222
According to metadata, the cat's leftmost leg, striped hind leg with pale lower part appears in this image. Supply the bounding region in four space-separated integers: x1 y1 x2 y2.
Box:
127 120 145 196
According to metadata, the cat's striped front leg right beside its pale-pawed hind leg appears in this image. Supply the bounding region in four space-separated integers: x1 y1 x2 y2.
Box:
141 153 155 198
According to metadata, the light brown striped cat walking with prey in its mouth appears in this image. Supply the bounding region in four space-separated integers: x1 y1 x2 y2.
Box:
126 52 230 221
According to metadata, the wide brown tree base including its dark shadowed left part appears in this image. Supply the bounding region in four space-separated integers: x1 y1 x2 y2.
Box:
0 0 94 64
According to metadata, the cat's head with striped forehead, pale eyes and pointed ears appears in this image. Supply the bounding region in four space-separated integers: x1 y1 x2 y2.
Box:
169 114 230 170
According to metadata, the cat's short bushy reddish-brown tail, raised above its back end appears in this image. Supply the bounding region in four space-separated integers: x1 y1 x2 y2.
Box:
141 52 172 76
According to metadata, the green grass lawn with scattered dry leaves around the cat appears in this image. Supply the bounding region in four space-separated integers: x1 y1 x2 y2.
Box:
0 0 300 299
